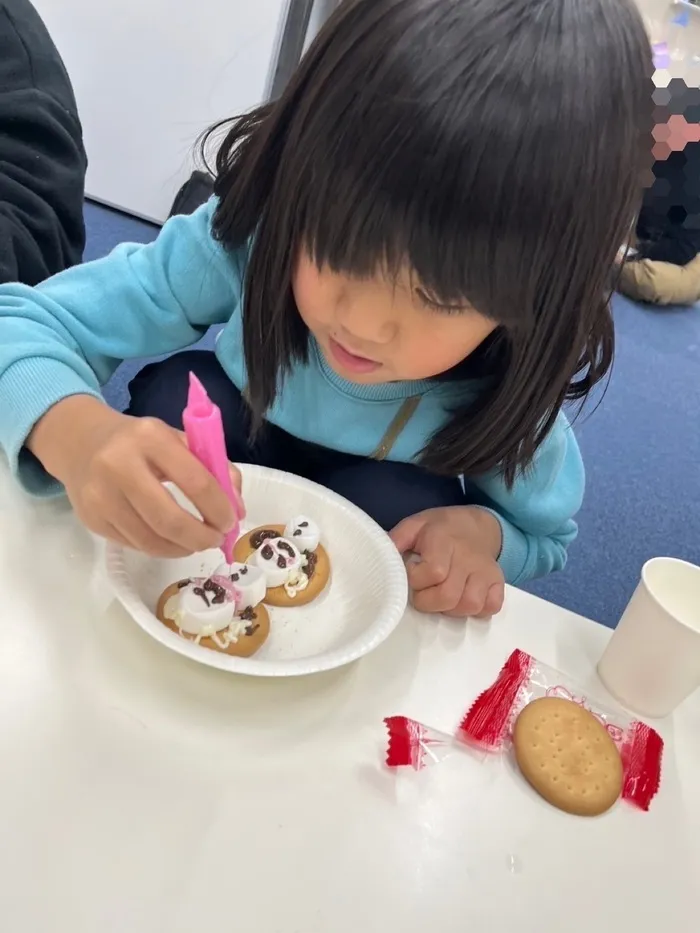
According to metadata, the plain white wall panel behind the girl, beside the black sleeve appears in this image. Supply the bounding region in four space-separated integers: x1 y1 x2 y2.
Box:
33 0 285 220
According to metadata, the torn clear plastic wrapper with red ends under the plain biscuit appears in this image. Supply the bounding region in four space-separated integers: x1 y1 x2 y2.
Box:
384 650 663 810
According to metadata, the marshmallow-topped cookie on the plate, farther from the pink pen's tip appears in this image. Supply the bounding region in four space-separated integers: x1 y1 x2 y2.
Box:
234 515 331 607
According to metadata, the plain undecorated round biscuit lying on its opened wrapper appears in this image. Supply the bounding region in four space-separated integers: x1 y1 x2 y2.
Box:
513 697 623 816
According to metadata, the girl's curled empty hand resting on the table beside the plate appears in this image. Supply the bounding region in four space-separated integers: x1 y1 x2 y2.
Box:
391 506 505 618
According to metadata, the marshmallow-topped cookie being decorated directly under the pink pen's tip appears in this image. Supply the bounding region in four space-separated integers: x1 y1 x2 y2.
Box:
156 565 270 658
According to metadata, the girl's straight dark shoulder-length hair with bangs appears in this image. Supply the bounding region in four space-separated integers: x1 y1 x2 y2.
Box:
205 0 653 483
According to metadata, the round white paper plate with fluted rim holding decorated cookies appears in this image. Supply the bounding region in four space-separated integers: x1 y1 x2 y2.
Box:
106 466 408 677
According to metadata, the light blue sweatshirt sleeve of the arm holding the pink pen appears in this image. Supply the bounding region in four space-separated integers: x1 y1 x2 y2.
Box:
0 200 243 492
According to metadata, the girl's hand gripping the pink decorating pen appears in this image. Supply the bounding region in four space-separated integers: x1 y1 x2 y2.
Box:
27 395 242 557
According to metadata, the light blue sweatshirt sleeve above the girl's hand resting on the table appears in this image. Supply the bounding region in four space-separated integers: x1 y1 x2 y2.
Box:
474 414 585 584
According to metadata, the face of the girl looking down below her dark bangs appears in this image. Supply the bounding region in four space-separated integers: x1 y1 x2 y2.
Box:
292 251 496 383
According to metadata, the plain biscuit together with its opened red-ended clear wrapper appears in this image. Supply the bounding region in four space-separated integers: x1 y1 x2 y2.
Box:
385 650 663 815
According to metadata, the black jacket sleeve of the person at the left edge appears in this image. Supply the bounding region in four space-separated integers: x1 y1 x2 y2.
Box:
0 0 87 285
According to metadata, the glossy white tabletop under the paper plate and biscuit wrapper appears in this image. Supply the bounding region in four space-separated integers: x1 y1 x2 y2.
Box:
0 465 700 933
